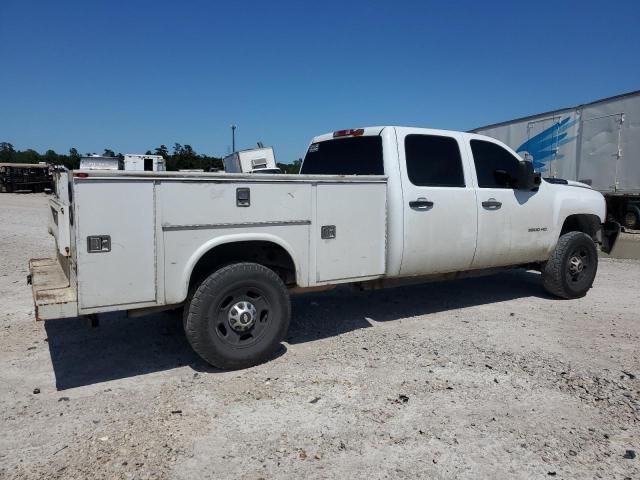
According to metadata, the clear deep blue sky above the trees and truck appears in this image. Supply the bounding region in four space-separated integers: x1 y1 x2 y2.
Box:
0 0 640 162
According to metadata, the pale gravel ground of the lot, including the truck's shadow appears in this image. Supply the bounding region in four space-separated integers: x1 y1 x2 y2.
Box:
0 194 640 480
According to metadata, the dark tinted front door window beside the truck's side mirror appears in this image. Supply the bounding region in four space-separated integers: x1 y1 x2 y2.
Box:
471 140 520 188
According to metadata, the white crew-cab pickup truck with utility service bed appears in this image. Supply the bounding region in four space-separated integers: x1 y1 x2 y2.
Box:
30 126 617 368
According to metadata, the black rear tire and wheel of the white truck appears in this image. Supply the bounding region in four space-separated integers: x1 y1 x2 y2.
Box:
184 263 291 369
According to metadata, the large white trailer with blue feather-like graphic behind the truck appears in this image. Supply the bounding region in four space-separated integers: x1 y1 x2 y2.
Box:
472 91 640 228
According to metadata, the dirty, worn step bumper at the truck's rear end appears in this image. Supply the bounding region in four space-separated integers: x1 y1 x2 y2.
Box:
29 258 78 320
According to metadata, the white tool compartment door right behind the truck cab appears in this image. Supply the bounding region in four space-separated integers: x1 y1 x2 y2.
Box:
313 183 386 282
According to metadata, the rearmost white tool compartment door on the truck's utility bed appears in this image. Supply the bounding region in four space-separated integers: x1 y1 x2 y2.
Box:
75 180 156 309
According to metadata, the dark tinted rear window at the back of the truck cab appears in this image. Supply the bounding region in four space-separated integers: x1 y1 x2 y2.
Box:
300 136 384 175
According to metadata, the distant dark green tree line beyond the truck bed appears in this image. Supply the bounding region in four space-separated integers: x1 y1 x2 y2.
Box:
0 142 302 173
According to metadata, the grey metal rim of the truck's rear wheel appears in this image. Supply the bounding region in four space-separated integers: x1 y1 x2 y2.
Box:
210 286 271 347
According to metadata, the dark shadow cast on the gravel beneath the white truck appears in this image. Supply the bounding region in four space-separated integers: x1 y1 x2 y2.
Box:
45 270 546 390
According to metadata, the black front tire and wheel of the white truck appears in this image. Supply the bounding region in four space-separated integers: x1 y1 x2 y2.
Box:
542 232 598 298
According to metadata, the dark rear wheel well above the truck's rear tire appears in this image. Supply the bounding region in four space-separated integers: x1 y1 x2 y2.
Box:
189 240 296 290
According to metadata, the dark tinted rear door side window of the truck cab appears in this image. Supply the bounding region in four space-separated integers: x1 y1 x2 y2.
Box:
404 135 465 187
